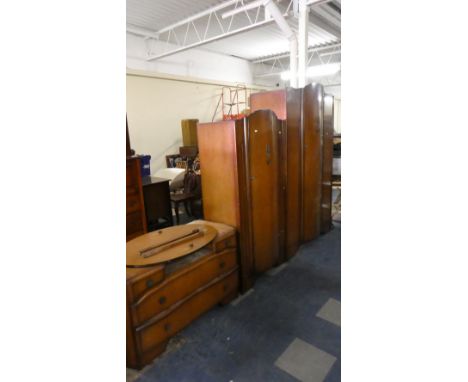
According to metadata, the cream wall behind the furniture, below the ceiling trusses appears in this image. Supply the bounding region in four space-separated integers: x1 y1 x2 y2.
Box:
127 70 268 173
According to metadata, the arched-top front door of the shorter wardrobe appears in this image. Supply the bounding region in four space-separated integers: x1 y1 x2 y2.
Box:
247 110 282 273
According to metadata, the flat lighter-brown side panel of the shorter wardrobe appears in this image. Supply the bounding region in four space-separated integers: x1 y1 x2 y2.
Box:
198 121 240 228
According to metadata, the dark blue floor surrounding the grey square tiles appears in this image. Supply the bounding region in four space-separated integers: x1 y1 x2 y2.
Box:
137 223 341 382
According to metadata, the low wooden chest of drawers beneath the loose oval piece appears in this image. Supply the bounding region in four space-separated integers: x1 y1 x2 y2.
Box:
127 220 239 369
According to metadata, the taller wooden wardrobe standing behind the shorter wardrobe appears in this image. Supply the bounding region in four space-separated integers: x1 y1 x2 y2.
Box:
250 84 333 243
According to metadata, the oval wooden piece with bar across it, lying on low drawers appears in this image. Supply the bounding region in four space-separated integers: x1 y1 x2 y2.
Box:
127 224 217 267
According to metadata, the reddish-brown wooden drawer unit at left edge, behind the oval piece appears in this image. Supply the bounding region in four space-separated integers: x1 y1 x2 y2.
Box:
126 157 147 241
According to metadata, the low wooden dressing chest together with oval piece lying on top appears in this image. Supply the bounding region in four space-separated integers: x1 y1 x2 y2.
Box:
126 220 239 369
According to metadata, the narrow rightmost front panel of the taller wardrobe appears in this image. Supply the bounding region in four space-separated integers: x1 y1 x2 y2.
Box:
320 95 333 233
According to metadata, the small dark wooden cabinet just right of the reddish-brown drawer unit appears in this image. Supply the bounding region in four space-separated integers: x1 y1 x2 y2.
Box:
142 176 173 231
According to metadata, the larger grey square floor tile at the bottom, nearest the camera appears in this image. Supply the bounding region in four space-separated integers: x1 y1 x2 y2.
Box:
275 338 336 382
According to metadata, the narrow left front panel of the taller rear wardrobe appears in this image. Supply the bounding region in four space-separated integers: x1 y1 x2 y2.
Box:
286 88 302 258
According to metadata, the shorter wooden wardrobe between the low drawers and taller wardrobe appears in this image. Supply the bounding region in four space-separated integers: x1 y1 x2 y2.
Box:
197 110 287 291
